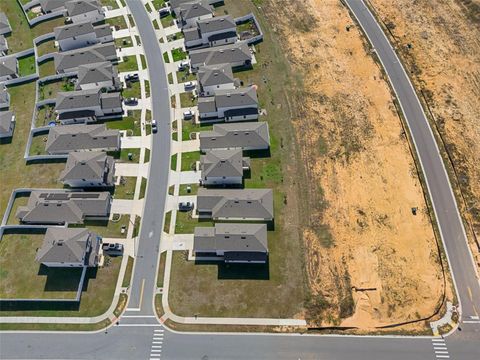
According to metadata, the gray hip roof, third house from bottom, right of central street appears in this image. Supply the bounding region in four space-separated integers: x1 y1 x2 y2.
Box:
200 149 244 178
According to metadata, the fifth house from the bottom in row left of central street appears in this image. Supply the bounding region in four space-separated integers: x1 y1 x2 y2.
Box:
55 89 123 125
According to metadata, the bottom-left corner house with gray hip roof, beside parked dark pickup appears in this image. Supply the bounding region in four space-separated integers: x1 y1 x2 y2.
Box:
35 227 102 267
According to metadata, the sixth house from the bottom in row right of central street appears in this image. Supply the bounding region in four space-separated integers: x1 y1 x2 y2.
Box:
197 64 235 96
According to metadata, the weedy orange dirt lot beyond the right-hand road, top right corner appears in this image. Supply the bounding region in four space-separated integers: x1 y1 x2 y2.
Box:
371 0 480 270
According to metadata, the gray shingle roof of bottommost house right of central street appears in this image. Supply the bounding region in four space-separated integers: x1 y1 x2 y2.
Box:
193 223 268 253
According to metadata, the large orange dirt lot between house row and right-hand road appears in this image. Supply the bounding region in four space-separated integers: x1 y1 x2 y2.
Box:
256 0 444 330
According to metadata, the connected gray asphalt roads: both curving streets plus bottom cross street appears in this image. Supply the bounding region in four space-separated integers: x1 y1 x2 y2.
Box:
0 0 480 360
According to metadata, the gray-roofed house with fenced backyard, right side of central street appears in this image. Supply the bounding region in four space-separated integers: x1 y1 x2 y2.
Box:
183 15 237 47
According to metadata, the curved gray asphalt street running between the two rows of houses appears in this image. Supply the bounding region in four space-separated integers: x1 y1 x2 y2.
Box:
123 0 171 315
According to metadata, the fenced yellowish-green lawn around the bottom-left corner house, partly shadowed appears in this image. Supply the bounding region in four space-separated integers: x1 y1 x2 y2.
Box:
0 234 82 299
